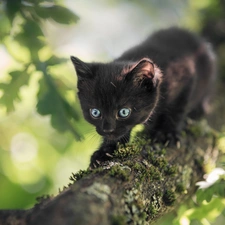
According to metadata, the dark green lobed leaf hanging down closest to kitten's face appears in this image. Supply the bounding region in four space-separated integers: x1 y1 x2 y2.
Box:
37 74 81 140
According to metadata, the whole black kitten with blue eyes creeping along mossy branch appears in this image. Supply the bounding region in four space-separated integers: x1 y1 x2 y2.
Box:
71 28 215 167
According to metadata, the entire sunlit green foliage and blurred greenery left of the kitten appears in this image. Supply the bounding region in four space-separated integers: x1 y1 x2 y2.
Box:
0 0 98 208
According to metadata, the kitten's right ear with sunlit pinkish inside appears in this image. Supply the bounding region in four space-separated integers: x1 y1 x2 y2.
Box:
126 58 162 86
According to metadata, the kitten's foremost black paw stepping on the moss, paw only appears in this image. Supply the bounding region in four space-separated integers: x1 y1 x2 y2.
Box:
90 146 115 169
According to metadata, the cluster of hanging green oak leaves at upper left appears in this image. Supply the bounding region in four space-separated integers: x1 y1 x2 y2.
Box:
0 0 81 139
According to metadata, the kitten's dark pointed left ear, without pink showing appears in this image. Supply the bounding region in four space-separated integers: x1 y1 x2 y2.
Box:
70 56 93 79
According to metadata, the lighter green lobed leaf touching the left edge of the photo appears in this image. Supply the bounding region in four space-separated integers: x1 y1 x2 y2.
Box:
0 71 30 112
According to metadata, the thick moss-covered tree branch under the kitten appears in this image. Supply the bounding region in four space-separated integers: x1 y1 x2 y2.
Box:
0 118 218 225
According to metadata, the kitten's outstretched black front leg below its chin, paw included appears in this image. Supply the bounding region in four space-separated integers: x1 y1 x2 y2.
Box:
90 133 130 168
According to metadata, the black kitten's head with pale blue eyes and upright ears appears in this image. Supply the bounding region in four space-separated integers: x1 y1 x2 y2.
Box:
71 57 161 140
